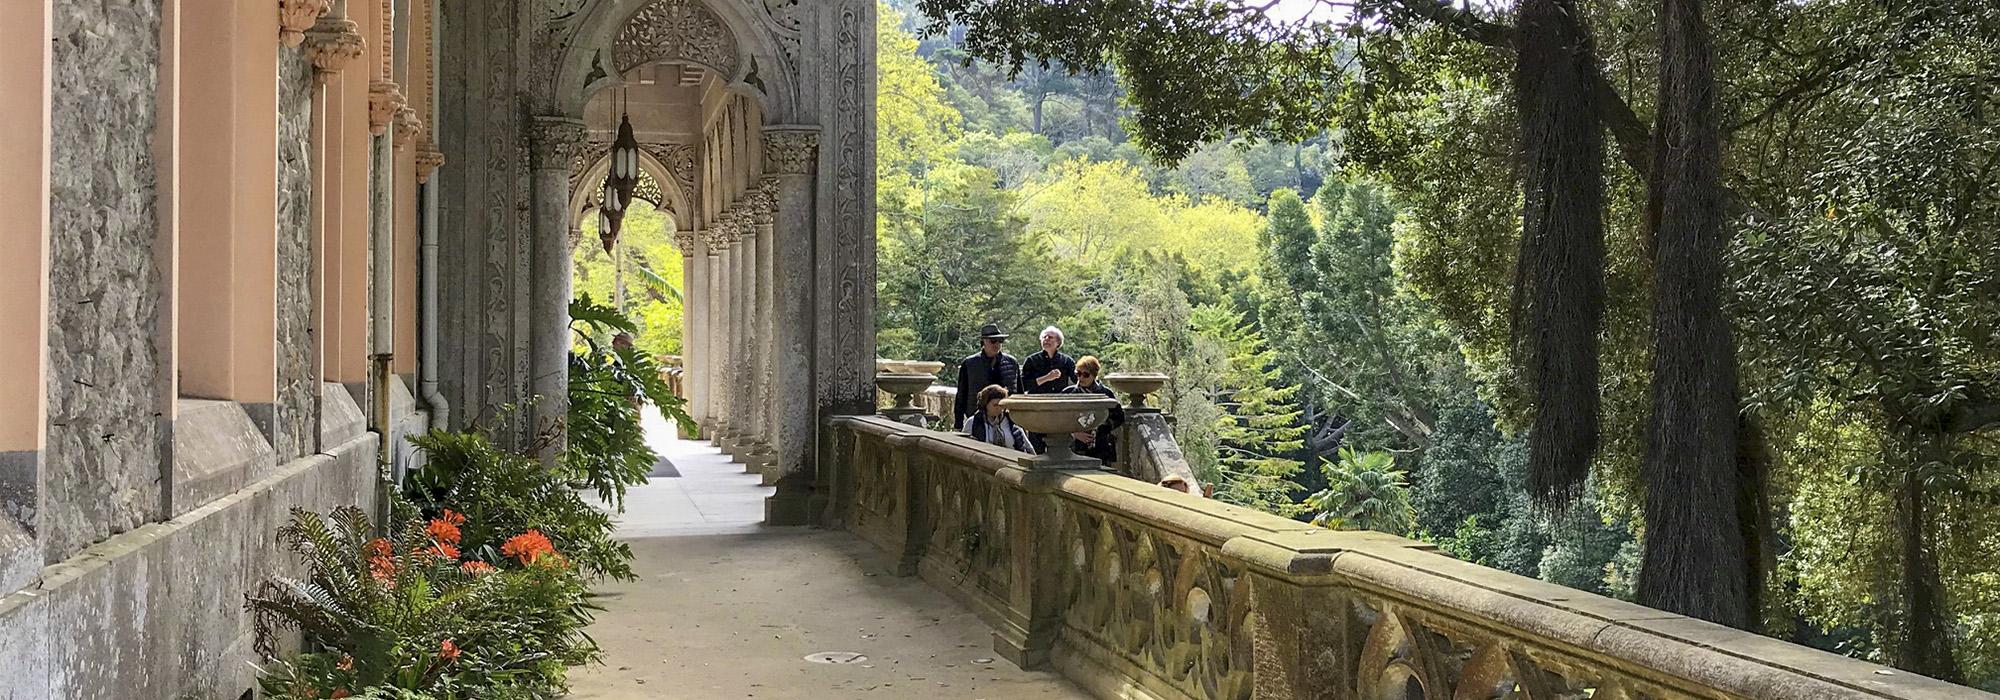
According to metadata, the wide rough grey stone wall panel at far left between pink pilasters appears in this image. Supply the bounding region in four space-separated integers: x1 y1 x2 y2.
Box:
40 0 170 562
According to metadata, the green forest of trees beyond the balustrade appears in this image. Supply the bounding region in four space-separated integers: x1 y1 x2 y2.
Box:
872 0 2000 690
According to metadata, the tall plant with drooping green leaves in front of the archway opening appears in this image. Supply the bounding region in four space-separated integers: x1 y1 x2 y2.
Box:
562 294 694 510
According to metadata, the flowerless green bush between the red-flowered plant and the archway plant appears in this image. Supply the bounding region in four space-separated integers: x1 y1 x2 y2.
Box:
404 430 634 580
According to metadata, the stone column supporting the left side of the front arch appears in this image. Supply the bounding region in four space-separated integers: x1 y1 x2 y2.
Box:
516 116 586 462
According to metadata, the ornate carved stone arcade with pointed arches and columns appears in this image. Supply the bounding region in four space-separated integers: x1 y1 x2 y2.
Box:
438 0 874 524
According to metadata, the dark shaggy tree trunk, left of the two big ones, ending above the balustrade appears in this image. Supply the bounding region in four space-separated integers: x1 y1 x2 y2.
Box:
1514 0 1604 508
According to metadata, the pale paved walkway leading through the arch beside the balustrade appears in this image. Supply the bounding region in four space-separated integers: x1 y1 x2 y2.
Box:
570 416 1088 700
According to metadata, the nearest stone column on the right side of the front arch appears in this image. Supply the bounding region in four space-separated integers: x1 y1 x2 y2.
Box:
764 126 820 526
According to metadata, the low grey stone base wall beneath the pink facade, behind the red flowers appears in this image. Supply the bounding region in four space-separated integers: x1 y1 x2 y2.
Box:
0 432 376 700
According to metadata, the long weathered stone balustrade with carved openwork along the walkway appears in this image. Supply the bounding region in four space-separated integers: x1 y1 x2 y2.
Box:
828 416 1994 700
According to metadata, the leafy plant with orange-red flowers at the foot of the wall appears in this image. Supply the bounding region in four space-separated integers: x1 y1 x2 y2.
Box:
248 502 598 700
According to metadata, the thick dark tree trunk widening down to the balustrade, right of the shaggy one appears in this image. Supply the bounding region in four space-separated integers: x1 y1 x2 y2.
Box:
1638 0 1752 628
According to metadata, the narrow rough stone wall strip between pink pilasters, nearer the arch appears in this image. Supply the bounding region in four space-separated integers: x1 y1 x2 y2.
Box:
272 48 320 462
